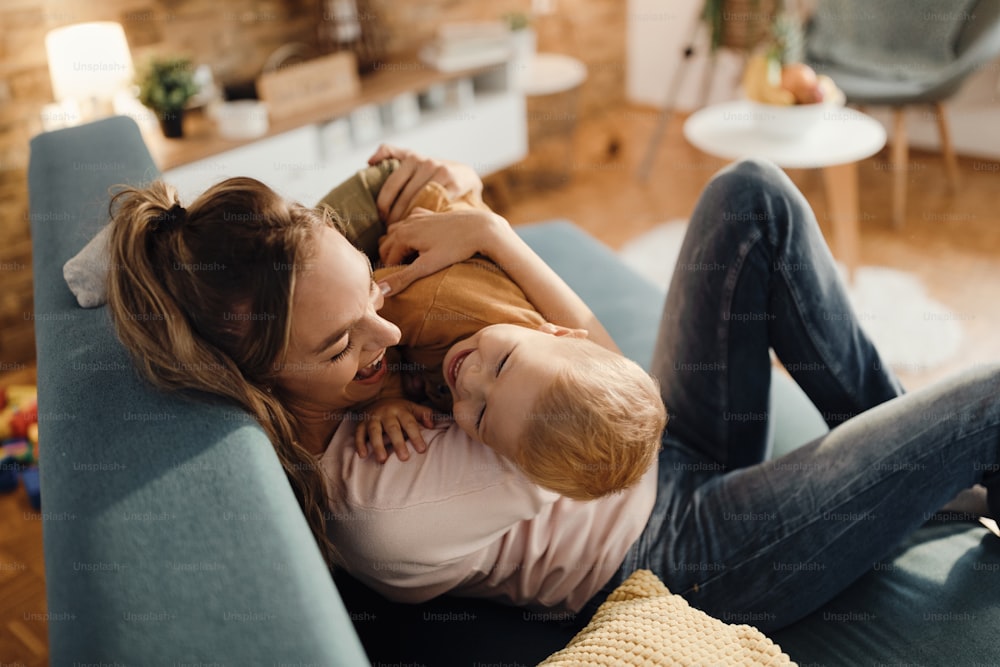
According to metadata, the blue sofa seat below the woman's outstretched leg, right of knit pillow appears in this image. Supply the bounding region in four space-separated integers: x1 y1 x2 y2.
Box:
771 521 1000 667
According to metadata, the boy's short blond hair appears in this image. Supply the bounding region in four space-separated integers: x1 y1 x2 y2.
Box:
514 338 667 500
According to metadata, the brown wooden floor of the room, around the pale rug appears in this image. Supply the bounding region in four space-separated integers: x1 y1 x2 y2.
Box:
0 102 1000 665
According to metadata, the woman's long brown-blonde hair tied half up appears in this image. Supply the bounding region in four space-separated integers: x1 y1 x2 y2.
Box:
108 178 336 565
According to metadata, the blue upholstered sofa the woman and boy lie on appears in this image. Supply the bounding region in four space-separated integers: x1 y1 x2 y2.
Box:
29 117 1000 667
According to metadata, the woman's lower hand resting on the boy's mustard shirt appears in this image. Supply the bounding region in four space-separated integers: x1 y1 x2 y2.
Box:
379 208 508 294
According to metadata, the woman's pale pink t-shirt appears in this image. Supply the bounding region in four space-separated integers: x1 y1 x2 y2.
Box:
320 422 656 612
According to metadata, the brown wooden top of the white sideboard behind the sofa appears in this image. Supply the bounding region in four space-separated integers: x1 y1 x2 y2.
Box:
144 57 506 171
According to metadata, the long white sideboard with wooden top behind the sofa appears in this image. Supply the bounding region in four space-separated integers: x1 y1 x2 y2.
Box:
147 62 528 205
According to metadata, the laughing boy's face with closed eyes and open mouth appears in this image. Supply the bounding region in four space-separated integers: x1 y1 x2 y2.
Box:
442 324 570 458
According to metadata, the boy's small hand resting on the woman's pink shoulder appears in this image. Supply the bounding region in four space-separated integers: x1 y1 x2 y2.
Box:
354 398 434 463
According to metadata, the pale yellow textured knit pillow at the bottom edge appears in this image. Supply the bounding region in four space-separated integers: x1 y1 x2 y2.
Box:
539 570 795 667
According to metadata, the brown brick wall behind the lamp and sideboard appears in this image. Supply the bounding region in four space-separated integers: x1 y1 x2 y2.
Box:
0 0 625 373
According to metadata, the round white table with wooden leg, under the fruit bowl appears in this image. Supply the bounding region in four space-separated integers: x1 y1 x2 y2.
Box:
684 101 886 279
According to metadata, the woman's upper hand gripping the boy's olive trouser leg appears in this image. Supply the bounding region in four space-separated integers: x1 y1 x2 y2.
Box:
368 144 483 226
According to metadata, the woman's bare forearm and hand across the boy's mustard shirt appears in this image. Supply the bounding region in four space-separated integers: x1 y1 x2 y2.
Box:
379 209 619 352
